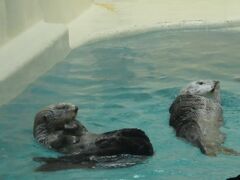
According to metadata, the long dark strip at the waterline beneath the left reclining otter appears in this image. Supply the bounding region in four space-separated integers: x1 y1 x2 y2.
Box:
33 154 147 172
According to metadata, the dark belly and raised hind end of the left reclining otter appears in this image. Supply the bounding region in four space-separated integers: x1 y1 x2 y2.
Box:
58 129 153 156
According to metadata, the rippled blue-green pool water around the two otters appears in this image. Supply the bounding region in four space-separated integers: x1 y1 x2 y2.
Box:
0 29 240 180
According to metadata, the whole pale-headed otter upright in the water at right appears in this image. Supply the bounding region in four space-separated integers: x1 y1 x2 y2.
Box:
169 80 240 156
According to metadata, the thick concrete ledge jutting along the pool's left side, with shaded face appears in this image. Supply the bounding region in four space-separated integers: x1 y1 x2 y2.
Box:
0 22 70 105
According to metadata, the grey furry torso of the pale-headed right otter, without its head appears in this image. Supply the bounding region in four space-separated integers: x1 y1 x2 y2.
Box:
170 95 224 154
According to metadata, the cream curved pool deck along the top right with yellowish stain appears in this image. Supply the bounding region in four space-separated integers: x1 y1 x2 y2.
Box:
68 0 240 48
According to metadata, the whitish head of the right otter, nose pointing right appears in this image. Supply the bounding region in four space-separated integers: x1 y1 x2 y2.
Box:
180 80 220 102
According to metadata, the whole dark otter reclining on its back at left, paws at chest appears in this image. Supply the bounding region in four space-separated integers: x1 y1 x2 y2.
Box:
33 103 153 171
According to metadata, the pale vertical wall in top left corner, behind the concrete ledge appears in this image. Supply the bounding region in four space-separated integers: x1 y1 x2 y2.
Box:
0 0 93 46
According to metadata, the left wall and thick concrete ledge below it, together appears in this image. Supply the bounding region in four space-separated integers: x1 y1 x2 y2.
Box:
0 0 93 105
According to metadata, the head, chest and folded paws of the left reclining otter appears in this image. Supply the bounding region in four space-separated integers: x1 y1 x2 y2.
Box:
33 103 83 152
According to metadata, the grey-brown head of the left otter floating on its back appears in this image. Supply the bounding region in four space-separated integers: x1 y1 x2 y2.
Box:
34 103 78 130
